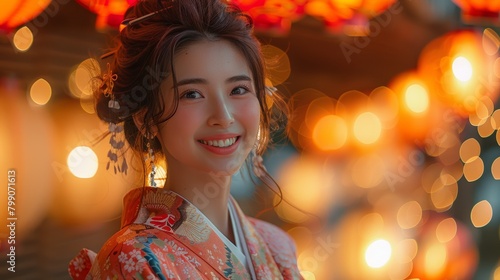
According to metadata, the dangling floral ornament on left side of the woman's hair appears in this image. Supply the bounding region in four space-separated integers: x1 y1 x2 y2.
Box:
100 63 128 174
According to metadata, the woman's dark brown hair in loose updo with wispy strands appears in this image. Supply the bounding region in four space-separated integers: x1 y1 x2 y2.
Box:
95 0 286 184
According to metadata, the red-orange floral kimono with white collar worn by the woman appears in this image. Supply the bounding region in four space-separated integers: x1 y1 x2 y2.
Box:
69 187 302 280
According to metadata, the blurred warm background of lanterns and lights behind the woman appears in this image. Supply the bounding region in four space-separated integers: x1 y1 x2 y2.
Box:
0 0 500 280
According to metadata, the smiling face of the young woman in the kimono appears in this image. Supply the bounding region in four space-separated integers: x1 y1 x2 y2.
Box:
158 40 260 177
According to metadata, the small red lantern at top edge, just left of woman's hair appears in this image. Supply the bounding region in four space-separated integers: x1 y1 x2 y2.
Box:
77 0 137 30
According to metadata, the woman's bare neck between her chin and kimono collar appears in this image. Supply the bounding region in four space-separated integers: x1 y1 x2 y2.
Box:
165 166 233 240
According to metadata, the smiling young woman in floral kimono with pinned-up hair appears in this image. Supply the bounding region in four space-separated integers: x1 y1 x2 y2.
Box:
69 0 302 279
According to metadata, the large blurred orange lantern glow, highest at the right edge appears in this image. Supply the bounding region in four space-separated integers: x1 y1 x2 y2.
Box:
418 31 497 115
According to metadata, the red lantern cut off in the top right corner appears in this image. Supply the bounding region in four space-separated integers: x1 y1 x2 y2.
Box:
453 0 500 24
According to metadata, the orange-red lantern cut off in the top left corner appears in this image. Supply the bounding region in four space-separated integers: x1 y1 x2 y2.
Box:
0 0 51 32
